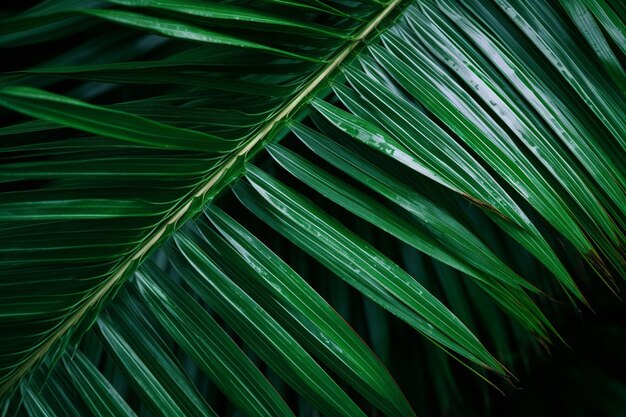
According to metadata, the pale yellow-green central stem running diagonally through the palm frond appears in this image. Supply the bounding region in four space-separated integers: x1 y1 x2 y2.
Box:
0 0 405 397
